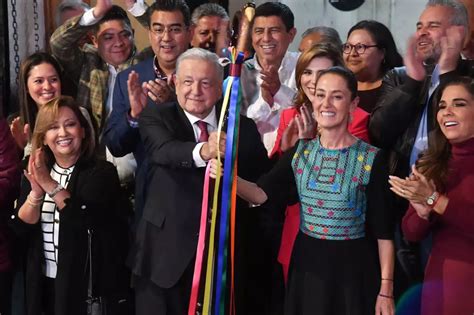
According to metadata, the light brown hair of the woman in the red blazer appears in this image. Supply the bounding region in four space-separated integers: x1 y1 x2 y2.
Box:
294 42 344 108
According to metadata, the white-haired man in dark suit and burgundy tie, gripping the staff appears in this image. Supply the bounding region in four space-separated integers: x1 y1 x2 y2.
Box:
130 48 268 315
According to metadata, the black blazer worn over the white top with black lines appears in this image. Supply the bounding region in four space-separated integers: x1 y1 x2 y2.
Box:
12 160 129 315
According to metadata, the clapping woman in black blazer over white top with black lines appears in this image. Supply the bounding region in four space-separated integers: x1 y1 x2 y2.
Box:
14 97 126 315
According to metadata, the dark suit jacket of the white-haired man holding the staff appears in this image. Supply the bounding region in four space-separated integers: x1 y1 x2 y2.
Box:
130 102 268 288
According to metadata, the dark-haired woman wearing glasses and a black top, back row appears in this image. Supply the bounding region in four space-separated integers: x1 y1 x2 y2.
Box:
342 20 403 113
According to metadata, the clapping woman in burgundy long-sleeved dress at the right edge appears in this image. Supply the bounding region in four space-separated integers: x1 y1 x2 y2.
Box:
390 77 474 315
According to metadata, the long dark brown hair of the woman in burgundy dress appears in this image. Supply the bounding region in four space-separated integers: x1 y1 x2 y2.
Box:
415 77 474 191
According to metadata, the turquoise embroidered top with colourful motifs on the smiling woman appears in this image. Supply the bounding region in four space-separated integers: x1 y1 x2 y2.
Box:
292 137 378 240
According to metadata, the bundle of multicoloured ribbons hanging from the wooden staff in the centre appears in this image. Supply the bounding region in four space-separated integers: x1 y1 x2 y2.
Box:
188 50 244 315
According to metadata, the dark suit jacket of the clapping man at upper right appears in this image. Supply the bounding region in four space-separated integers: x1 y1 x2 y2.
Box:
369 60 474 177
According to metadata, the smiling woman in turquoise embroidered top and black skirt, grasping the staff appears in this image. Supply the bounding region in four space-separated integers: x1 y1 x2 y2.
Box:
220 67 394 315
